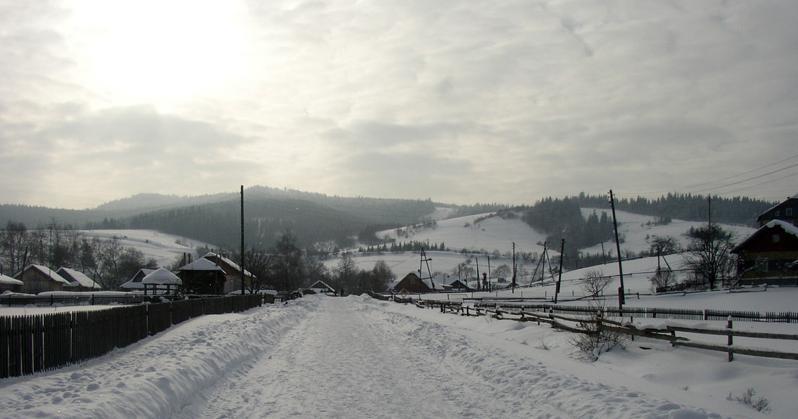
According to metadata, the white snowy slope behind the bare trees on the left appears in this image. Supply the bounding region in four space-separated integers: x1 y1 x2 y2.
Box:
81 230 213 266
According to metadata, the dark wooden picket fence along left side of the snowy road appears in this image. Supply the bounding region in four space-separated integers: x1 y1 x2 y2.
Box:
0 295 263 378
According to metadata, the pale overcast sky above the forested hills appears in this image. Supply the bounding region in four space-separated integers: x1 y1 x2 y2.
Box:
0 0 798 208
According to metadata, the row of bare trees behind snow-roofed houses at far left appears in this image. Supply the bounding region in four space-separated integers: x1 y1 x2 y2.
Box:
0 221 157 289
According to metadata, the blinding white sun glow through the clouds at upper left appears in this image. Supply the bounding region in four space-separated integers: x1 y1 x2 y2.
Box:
69 0 248 107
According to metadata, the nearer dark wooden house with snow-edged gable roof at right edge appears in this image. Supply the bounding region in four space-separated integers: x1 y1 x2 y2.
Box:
731 220 798 286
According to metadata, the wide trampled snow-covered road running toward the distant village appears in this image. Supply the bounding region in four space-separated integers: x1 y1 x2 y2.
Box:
181 297 736 418
